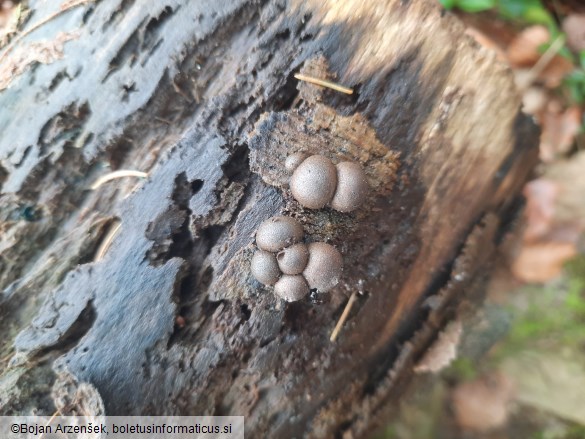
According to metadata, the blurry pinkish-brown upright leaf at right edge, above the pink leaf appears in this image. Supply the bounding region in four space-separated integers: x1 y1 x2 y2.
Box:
540 101 582 162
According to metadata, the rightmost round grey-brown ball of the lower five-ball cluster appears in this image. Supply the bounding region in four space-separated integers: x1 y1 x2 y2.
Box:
303 242 343 293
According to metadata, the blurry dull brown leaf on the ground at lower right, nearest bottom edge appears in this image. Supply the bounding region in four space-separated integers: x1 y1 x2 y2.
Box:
452 373 514 432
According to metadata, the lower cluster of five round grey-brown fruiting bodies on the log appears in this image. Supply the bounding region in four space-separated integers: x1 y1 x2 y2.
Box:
251 216 343 302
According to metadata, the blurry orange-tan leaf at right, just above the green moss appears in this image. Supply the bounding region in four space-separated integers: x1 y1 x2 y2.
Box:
512 242 577 283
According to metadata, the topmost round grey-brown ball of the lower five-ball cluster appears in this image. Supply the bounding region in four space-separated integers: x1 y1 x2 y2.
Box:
256 216 304 252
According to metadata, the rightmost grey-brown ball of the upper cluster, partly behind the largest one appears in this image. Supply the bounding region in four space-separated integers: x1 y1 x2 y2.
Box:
330 162 369 212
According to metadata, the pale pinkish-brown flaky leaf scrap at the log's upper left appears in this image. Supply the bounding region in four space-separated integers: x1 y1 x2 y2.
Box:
0 30 80 90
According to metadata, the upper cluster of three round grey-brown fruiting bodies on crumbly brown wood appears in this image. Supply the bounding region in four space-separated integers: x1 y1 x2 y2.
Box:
285 153 369 212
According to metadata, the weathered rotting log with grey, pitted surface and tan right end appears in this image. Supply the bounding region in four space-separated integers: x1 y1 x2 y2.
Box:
0 0 538 437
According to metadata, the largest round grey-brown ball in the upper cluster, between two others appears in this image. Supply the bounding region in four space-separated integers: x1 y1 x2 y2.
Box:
290 155 337 209
